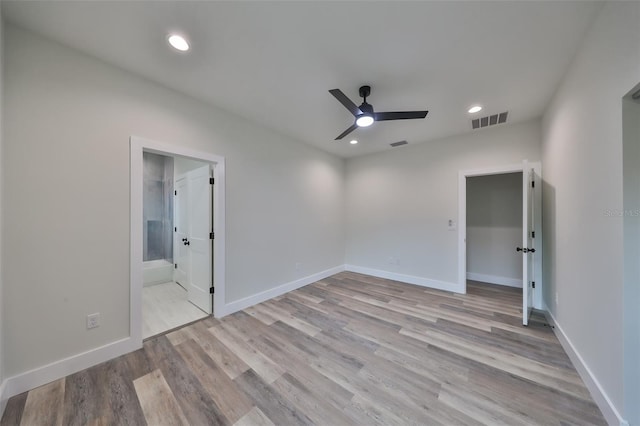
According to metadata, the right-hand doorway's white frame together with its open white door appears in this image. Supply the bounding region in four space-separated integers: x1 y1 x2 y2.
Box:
458 160 542 325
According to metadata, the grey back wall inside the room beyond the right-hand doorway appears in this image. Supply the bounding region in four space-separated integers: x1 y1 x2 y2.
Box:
467 173 522 287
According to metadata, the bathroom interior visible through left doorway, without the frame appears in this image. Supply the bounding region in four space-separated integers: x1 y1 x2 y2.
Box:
142 152 213 338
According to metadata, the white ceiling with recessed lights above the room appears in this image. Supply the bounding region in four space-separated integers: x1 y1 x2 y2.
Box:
2 1 601 157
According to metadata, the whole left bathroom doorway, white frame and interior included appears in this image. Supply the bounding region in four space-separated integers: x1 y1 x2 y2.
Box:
130 137 225 344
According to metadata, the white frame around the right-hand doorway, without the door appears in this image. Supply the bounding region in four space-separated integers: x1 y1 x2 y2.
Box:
458 162 544 309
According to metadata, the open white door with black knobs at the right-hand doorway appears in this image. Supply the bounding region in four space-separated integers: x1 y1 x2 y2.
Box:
518 160 540 325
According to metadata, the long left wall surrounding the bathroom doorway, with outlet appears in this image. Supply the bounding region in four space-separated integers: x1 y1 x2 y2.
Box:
3 25 344 376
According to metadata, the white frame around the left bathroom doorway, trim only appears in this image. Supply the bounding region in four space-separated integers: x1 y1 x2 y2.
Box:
129 136 226 346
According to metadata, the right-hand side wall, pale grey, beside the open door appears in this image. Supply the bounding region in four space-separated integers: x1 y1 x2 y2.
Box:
542 2 640 424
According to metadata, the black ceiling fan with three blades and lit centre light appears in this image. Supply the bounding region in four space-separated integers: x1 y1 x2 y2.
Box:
329 86 429 140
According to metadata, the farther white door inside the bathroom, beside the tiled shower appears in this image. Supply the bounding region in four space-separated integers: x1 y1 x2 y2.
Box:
173 176 191 290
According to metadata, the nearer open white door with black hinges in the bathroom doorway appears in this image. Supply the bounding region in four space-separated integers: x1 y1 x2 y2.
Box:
187 165 213 314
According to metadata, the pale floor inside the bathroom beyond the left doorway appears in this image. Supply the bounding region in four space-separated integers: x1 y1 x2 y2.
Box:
142 282 207 339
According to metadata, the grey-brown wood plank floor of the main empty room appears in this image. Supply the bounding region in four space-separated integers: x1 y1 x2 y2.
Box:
1 272 605 426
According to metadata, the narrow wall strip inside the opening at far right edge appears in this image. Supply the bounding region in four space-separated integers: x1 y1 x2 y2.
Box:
622 94 640 424
